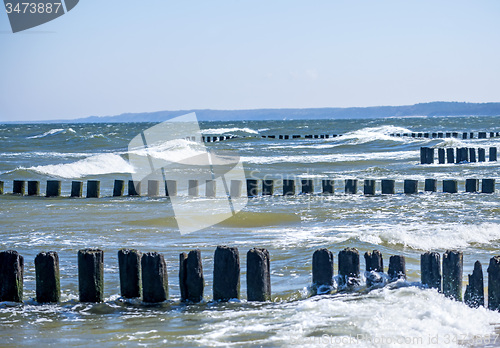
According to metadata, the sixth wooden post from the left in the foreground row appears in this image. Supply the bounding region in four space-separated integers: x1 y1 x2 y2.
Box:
179 249 205 303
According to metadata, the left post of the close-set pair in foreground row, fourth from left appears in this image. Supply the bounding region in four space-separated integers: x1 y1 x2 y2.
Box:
118 249 142 298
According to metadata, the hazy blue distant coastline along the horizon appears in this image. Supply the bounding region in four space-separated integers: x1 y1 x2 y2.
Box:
0 102 500 124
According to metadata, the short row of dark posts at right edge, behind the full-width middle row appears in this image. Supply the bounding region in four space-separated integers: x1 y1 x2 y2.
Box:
420 147 497 164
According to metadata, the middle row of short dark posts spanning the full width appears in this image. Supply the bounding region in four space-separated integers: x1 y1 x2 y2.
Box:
0 178 495 198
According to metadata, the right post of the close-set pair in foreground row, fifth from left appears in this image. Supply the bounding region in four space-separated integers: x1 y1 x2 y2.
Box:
141 252 168 303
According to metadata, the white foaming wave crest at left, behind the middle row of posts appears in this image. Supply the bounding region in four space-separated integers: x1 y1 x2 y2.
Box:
27 153 134 179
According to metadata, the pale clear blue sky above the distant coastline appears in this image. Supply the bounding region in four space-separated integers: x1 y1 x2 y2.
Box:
0 0 500 121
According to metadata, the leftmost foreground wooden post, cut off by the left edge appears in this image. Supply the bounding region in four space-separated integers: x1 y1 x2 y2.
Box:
0 250 24 302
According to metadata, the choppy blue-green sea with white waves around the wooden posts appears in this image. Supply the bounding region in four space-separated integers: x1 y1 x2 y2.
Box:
0 116 500 347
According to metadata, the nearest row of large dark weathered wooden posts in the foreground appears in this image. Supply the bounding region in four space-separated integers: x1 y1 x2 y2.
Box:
0 246 500 310
